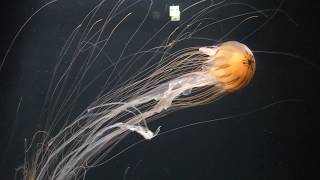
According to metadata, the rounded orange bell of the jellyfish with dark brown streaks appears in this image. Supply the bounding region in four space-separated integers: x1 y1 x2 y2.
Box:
199 41 256 92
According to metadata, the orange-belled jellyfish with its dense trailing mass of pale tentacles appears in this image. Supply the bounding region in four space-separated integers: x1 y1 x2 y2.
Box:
20 38 256 180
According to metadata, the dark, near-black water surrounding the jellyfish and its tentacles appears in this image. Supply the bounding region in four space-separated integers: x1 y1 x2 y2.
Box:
0 0 320 180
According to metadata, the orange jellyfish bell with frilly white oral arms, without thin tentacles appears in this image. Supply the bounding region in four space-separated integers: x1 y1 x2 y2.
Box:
114 41 256 139
